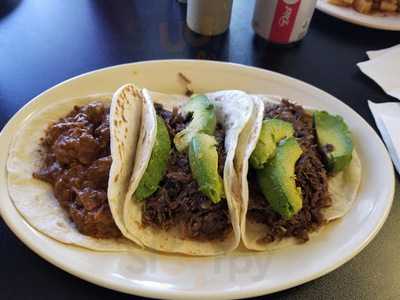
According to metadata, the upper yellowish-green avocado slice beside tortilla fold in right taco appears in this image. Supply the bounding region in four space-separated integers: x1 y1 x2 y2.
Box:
250 119 294 169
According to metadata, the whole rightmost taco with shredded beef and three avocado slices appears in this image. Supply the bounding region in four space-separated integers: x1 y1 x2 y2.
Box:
235 95 361 251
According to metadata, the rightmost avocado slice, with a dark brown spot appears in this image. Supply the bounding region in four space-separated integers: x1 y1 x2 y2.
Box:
313 111 353 174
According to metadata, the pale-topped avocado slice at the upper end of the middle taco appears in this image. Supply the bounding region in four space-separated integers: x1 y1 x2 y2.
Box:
174 95 217 152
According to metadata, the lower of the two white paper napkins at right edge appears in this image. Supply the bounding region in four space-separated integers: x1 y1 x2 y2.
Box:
368 101 400 174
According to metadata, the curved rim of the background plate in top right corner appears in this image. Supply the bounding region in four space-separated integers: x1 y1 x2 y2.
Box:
316 0 400 31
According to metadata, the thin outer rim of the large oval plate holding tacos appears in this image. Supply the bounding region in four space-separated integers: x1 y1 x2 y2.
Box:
0 59 395 299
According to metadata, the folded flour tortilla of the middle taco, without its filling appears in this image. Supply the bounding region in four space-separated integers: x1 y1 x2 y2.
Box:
123 91 253 256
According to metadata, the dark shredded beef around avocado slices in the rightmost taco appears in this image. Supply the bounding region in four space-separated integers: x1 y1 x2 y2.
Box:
248 100 331 243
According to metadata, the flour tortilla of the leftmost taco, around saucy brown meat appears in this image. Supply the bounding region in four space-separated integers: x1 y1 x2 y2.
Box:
7 87 142 251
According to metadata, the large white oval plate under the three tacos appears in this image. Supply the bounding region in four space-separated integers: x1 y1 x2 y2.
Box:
0 60 394 299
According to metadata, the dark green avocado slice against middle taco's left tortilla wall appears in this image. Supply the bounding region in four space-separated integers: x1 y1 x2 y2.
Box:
135 116 171 201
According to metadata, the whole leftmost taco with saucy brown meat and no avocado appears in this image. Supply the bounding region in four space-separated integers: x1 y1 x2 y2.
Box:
7 85 144 251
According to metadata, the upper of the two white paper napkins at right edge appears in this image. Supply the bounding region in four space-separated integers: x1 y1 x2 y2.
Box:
357 45 400 100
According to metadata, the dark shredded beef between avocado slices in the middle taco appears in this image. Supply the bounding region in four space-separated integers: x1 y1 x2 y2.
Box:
142 105 231 241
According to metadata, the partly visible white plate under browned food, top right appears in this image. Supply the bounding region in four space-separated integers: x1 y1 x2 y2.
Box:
317 0 400 31
